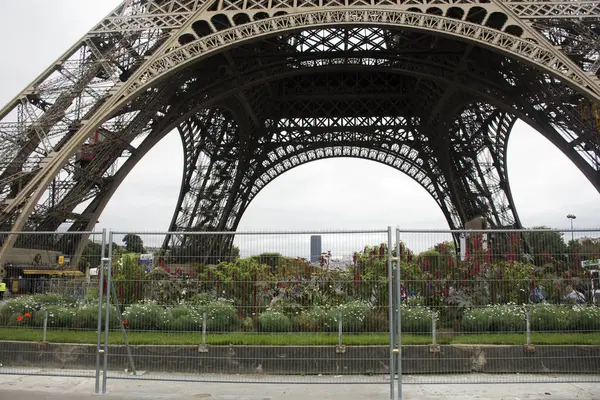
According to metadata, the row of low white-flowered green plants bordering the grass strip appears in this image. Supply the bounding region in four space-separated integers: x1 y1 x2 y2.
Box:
0 295 600 334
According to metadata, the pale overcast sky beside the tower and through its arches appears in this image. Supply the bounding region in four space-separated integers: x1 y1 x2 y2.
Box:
0 0 600 248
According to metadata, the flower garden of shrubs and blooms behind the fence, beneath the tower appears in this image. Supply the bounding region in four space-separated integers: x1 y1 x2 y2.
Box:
0 233 600 344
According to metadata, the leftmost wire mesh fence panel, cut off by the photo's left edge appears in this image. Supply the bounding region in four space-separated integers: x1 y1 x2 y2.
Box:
0 232 103 377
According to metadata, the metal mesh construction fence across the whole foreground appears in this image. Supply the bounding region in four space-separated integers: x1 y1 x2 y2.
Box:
0 229 600 398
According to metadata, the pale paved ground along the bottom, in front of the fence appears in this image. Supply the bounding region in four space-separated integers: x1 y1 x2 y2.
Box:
0 375 600 400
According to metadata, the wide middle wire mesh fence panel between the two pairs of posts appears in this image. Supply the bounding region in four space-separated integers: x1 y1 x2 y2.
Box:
101 230 390 383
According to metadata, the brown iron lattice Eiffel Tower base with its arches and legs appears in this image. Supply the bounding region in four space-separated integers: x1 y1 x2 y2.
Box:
0 0 600 264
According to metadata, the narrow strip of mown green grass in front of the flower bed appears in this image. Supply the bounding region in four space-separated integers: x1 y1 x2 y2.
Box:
0 328 600 346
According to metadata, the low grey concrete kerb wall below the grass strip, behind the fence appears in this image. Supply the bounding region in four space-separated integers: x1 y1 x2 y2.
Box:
0 341 600 375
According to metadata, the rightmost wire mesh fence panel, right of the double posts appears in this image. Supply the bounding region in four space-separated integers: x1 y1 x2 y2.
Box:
394 230 600 383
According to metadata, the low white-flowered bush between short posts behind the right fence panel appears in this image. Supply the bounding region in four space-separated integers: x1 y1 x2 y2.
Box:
462 305 525 332
